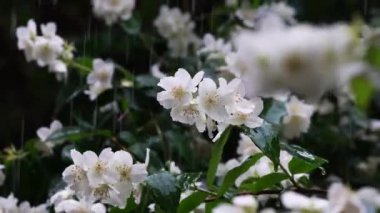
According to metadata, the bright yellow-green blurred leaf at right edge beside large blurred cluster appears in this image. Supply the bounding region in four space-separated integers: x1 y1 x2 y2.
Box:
351 75 375 110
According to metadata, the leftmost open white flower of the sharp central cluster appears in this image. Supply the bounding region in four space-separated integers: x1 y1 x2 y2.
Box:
157 68 204 109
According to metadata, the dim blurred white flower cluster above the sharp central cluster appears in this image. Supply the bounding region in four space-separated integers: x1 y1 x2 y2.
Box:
154 6 198 57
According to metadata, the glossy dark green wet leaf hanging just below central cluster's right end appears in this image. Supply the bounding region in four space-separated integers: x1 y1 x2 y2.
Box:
244 122 280 169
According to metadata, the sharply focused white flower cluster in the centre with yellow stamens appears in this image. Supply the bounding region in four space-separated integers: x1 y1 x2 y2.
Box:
157 68 263 140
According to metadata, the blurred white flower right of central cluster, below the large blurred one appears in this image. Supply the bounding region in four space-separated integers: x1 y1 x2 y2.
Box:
283 96 314 139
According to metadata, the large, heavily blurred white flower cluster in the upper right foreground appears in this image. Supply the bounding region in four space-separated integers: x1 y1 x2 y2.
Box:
225 25 362 98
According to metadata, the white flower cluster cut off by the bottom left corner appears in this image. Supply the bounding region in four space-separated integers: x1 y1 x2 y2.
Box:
0 194 49 213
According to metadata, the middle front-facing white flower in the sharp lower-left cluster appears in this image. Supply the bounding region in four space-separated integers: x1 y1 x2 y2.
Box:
83 148 116 187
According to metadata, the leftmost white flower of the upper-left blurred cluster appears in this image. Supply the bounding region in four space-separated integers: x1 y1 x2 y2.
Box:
16 19 37 61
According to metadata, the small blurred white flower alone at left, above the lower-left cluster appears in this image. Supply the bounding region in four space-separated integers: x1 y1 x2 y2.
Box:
36 120 62 155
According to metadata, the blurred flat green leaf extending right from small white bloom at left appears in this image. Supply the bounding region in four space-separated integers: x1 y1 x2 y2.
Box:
46 127 112 142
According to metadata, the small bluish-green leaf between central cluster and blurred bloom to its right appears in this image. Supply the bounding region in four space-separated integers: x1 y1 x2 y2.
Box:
262 99 286 124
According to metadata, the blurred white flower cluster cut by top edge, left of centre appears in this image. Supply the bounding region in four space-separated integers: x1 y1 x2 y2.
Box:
92 0 135 25
